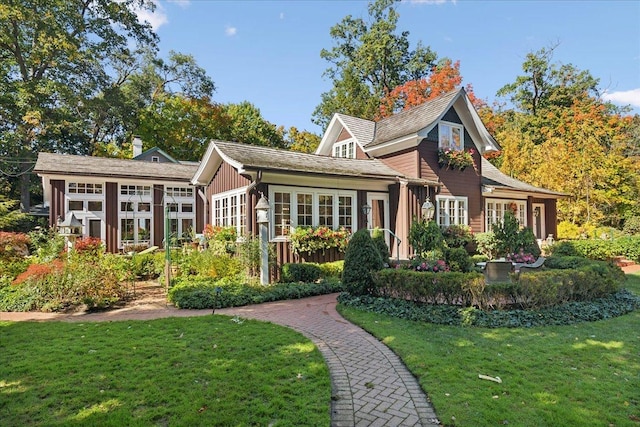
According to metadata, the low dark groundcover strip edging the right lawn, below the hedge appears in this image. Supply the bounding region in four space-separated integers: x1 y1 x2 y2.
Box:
338 289 640 328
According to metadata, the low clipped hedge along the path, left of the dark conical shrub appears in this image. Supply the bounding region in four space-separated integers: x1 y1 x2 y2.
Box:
168 277 343 309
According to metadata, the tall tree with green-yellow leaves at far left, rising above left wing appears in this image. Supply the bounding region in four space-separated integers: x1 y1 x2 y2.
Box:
0 0 157 210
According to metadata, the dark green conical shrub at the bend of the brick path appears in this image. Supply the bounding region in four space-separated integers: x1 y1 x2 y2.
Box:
342 228 383 295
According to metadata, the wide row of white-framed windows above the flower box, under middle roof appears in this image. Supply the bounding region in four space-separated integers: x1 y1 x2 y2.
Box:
269 186 357 238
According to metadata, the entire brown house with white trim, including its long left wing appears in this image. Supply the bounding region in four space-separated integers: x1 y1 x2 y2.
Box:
35 89 563 265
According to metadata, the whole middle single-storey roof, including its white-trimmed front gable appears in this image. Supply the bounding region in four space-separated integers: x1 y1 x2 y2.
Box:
191 141 430 185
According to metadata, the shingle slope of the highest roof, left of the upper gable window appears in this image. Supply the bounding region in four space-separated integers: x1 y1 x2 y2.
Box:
366 89 462 148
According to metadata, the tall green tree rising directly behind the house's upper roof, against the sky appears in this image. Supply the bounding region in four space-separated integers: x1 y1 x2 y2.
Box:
313 0 436 127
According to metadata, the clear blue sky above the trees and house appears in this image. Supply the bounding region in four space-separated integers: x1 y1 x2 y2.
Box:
142 0 640 134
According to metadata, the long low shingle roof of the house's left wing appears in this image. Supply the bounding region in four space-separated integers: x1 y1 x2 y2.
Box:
34 153 198 181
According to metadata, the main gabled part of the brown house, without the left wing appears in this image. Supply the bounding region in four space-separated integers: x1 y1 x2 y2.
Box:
191 89 563 262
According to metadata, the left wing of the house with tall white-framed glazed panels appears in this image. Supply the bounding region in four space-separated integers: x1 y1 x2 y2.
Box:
34 138 204 252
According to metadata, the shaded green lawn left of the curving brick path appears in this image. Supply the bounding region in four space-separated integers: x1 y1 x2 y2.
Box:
0 316 331 427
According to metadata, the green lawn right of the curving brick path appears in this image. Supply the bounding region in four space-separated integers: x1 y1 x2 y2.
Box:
339 274 640 427
